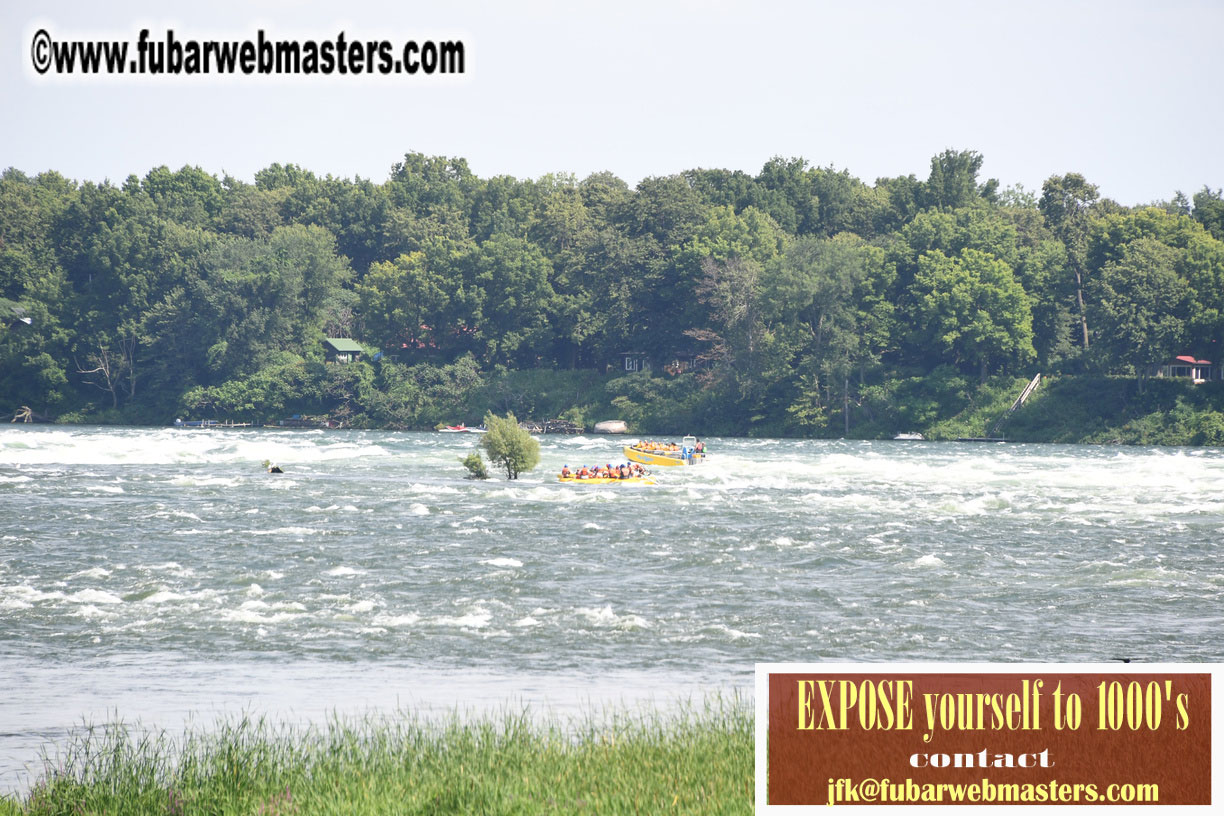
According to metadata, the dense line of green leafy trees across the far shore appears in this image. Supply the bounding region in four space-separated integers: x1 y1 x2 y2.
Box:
0 150 1224 434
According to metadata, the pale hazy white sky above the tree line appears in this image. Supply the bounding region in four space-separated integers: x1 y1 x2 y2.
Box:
0 0 1224 204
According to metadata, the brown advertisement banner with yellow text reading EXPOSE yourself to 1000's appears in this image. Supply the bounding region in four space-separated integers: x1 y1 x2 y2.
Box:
766 667 1212 805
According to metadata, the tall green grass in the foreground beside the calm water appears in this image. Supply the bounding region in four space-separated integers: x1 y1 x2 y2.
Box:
0 700 753 816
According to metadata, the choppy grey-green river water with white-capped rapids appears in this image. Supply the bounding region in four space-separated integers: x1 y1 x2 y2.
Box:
0 427 1224 784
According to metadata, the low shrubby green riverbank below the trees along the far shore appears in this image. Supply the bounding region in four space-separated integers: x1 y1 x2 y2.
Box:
16 358 1224 445
